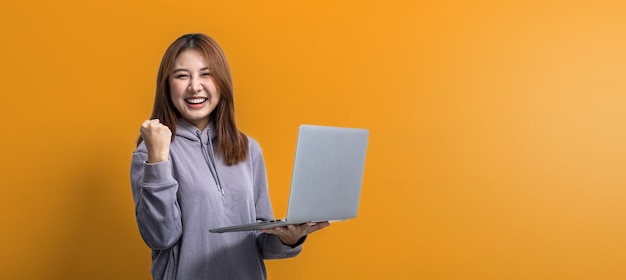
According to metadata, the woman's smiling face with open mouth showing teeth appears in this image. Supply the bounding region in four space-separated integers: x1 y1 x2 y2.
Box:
169 50 220 130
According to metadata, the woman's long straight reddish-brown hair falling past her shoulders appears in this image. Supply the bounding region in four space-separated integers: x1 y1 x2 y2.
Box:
137 33 248 165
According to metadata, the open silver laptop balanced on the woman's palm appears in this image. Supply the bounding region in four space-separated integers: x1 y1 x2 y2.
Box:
209 125 369 233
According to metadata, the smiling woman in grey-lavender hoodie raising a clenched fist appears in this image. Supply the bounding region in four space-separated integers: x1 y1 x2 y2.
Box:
130 34 328 279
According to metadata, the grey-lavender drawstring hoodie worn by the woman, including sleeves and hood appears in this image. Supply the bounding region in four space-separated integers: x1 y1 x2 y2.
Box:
130 119 302 280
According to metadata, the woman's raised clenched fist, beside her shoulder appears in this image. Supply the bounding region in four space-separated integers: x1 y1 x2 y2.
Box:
139 119 172 163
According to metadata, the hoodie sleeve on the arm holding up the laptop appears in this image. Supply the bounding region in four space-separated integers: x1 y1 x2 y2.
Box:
249 138 304 259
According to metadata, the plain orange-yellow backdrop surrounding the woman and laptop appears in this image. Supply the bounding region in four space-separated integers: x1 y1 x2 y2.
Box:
0 0 626 279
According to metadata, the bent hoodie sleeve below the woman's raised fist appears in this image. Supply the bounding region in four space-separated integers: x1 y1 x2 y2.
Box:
130 143 182 250
